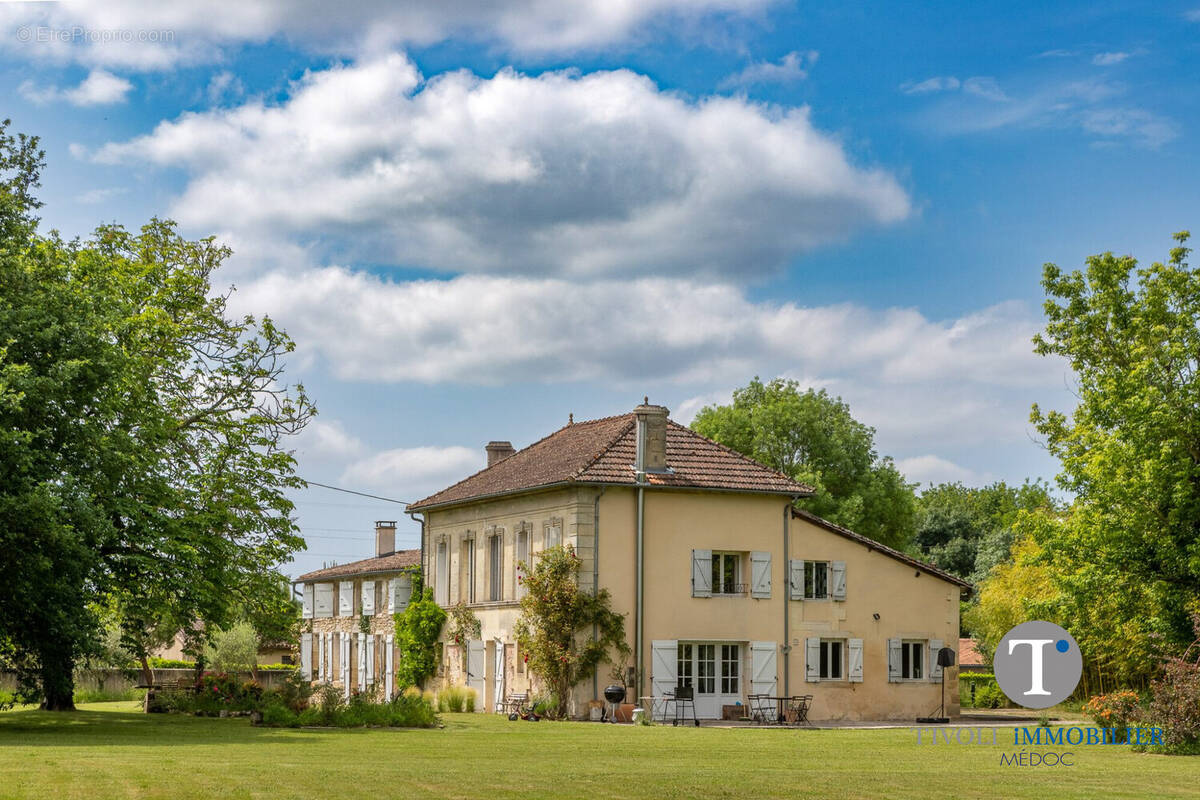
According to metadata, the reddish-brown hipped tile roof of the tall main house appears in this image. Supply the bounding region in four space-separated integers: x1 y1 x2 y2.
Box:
408 414 812 511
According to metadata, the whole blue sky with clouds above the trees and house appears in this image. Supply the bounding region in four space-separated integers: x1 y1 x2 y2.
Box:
0 0 1200 576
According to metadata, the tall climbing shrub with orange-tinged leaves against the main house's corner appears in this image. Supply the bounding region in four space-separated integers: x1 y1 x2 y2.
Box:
514 547 629 718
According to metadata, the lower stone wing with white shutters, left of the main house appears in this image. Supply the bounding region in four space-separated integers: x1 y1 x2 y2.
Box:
296 521 421 697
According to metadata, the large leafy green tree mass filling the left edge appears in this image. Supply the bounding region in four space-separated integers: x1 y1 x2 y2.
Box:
0 124 314 709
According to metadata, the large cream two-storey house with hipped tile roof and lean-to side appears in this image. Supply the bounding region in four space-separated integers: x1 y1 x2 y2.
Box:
408 402 970 720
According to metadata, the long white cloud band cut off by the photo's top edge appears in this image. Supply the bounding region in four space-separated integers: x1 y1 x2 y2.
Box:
0 0 773 70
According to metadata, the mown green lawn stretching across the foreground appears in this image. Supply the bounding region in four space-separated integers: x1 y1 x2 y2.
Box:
0 703 1200 800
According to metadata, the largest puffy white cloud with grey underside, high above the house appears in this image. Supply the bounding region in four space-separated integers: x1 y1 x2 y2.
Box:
94 54 911 279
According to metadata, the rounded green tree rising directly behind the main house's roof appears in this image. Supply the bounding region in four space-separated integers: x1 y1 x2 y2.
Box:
691 378 916 547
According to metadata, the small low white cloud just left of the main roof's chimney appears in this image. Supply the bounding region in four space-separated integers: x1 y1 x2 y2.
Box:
338 446 486 503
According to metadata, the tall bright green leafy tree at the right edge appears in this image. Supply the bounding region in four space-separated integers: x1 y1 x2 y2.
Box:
1032 233 1200 674
